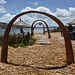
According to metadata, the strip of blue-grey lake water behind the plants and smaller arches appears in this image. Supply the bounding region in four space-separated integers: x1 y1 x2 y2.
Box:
0 28 53 35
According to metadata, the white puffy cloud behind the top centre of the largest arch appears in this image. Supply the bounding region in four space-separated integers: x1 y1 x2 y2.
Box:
21 7 53 25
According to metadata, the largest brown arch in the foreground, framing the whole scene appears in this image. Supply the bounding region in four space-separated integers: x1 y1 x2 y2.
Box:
1 11 74 63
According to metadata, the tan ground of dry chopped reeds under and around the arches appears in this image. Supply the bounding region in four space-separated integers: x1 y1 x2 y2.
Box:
0 32 75 75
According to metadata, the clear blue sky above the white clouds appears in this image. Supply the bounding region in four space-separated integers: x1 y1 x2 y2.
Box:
0 0 75 13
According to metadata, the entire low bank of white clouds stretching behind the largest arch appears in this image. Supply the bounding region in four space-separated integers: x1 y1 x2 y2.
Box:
0 7 75 26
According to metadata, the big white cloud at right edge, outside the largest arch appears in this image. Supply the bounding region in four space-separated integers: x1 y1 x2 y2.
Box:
54 7 75 25
